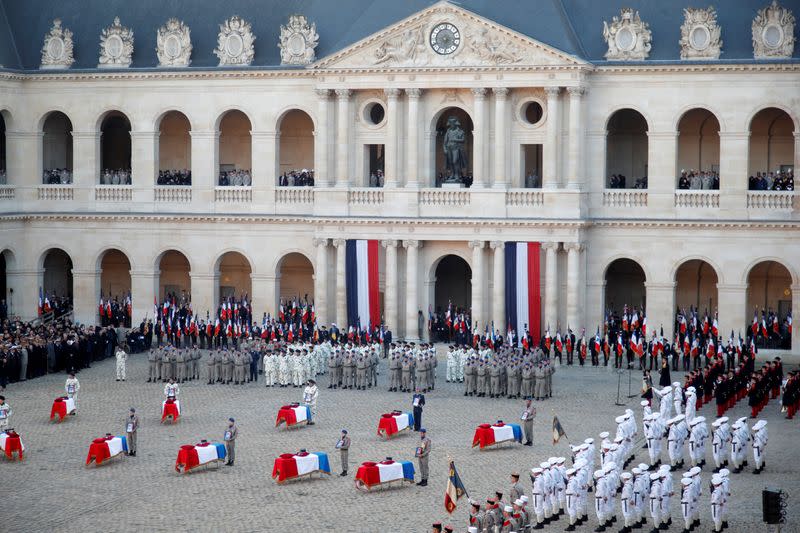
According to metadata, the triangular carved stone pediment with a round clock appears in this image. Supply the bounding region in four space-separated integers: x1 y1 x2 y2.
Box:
311 1 589 70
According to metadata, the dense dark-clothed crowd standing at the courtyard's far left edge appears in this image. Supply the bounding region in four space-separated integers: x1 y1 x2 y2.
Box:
0 318 125 391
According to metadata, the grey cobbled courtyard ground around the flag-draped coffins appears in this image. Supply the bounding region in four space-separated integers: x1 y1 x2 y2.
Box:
0 354 800 532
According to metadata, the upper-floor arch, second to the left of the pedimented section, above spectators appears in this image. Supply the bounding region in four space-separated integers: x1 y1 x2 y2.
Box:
215 108 254 183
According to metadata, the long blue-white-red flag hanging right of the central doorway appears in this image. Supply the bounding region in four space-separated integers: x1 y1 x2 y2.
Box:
505 242 542 339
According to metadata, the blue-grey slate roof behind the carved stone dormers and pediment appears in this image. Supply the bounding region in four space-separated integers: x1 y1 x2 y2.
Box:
0 0 800 70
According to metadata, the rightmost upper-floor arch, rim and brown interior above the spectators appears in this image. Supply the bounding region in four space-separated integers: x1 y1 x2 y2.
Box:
748 106 798 178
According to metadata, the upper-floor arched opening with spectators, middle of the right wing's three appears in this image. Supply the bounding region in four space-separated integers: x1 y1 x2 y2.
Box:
678 108 719 190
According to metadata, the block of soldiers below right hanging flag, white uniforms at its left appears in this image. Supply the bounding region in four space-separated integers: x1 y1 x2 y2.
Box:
447 345 555 400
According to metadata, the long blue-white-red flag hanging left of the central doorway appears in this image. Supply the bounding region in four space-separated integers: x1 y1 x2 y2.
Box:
345 239 382 329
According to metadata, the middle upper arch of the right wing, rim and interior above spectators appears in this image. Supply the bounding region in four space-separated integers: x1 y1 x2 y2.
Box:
676 107 722 185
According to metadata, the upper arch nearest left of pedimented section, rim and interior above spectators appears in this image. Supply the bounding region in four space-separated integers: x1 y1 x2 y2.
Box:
275 107 315 181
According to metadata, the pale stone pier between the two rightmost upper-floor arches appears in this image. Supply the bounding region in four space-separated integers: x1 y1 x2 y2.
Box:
719 131 750 210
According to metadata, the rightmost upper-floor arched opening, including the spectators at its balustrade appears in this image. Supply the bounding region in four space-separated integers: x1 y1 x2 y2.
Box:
748 107 795 190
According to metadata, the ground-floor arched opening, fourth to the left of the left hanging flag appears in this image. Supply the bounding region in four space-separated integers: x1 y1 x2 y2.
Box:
98 249 133 327
